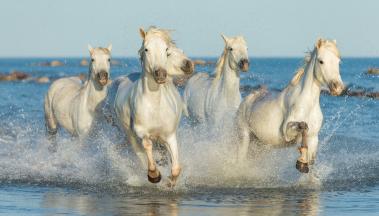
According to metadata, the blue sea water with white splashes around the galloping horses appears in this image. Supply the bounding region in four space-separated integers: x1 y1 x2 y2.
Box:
0 58 379 215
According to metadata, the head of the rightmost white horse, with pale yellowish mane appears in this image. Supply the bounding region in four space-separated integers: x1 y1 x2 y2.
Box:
315 39 344 96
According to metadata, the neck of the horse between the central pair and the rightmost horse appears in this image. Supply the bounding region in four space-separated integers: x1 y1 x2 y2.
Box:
218 59 241 100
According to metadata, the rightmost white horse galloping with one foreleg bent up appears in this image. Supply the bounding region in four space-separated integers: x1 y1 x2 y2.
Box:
237 39 344 173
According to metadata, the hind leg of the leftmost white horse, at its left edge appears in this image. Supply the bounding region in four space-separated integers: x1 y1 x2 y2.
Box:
44 95 58 152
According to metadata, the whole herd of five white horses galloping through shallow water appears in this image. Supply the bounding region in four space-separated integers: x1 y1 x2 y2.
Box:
44 27 344 186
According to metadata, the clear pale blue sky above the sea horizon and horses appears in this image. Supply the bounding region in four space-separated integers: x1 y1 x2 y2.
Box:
0 0 379 57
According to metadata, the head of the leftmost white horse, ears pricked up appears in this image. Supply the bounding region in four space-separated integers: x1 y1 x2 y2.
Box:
88 45 112 86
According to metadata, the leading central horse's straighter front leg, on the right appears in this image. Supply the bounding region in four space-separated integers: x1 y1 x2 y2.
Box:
167 133 181 187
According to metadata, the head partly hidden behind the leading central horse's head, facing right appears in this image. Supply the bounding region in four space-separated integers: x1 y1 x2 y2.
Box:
167 46 194 76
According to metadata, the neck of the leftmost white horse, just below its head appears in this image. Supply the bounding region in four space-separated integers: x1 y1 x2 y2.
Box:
81 79 107 113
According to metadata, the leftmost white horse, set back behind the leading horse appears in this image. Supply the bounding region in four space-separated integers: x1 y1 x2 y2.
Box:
44 45 112 142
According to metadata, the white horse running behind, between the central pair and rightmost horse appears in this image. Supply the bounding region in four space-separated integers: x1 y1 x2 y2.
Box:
184 35 249 124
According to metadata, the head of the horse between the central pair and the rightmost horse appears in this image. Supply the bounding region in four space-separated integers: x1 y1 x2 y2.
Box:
221 34 249 72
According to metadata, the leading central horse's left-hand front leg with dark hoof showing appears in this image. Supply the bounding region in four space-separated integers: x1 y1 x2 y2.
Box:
142 136 162 183
